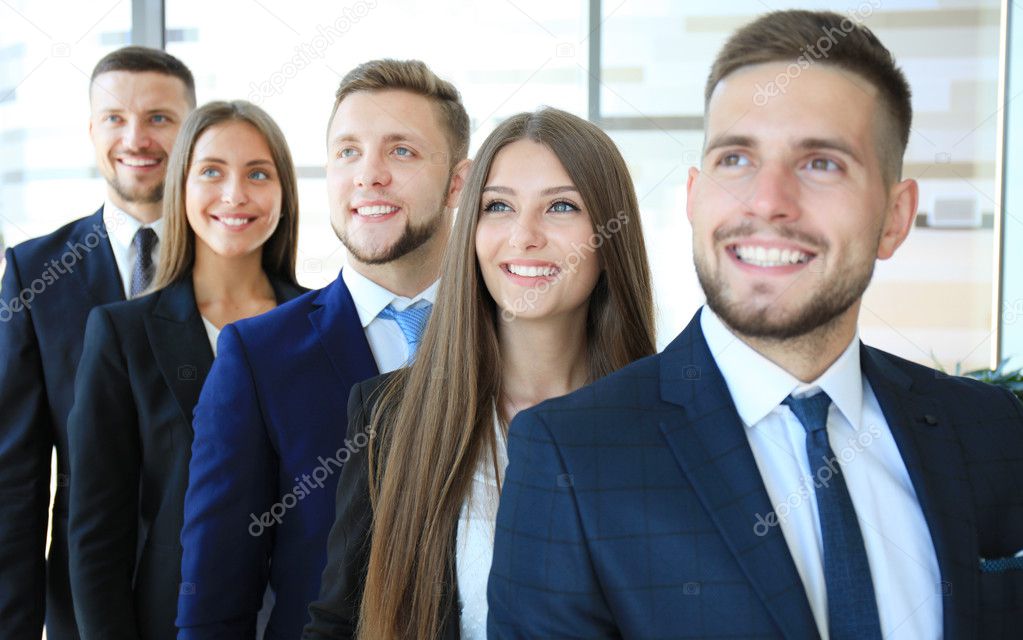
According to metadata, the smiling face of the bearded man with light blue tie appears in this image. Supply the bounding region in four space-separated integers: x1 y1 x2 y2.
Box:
326 90 457 265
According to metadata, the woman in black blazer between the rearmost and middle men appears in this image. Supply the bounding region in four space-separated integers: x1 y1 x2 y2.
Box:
68 100 303 640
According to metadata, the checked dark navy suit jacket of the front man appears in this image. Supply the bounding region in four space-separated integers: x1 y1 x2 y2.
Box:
488 314 1023 639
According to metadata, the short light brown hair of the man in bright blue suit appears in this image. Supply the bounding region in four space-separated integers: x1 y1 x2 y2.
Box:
327 59 469 167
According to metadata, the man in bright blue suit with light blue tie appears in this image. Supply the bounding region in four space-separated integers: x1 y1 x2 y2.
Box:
177 60 469 640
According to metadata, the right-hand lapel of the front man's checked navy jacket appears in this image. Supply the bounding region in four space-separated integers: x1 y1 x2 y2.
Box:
860 346 979 638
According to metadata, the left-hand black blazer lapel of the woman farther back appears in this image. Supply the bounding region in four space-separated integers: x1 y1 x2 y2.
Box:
145 277 213 425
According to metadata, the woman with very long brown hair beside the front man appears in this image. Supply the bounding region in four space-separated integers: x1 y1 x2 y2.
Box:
305 108 655 640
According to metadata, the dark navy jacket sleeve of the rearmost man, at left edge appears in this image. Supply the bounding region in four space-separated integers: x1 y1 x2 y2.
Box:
0 248 54 640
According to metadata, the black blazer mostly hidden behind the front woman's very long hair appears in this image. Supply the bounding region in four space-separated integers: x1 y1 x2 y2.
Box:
302 373 461 640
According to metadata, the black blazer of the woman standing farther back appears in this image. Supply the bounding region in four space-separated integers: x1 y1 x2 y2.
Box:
68 277 304 640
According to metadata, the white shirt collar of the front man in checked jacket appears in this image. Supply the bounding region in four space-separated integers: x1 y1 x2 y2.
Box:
700 306 863 429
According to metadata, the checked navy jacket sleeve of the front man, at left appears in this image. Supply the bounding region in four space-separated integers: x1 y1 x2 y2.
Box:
487 410 619 640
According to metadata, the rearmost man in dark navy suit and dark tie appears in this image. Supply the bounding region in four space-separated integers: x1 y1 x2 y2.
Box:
0 47 195 640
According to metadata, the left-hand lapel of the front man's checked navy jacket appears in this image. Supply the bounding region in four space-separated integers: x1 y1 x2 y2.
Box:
661 313 818 638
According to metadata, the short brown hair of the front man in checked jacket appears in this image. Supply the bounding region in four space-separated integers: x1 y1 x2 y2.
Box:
704 10 913 184
